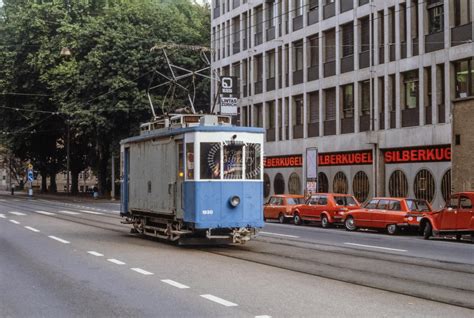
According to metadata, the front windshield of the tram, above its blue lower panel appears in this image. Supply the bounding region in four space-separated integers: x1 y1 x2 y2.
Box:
199 142 262 180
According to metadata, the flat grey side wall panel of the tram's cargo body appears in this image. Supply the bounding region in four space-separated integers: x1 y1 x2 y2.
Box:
130 139 179 217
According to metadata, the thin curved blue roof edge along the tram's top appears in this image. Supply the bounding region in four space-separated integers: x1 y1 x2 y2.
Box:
120 125 265 145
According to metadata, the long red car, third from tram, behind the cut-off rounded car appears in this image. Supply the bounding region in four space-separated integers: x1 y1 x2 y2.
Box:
344 198 432 235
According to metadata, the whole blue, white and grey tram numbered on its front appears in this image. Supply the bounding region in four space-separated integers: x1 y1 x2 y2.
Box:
121 114 264 243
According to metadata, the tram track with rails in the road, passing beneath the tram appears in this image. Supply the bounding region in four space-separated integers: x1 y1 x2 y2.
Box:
1 200 474 309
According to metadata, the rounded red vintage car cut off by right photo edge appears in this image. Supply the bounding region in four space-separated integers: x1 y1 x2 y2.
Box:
420 192 474 240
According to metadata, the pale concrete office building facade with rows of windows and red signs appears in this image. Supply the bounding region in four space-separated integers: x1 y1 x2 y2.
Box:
211 0 474 207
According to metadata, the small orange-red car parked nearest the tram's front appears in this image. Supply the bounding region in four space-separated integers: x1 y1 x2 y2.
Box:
263 194 304 223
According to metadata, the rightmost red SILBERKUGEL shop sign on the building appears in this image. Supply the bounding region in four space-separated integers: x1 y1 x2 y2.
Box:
384 145 451 163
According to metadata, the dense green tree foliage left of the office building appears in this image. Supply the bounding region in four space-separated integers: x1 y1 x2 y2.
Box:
0 0 210 194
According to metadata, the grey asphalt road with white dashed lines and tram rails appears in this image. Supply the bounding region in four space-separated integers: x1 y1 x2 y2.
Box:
0 196 474 317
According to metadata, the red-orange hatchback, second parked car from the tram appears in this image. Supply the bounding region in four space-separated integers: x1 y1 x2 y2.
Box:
293 193 360 228
